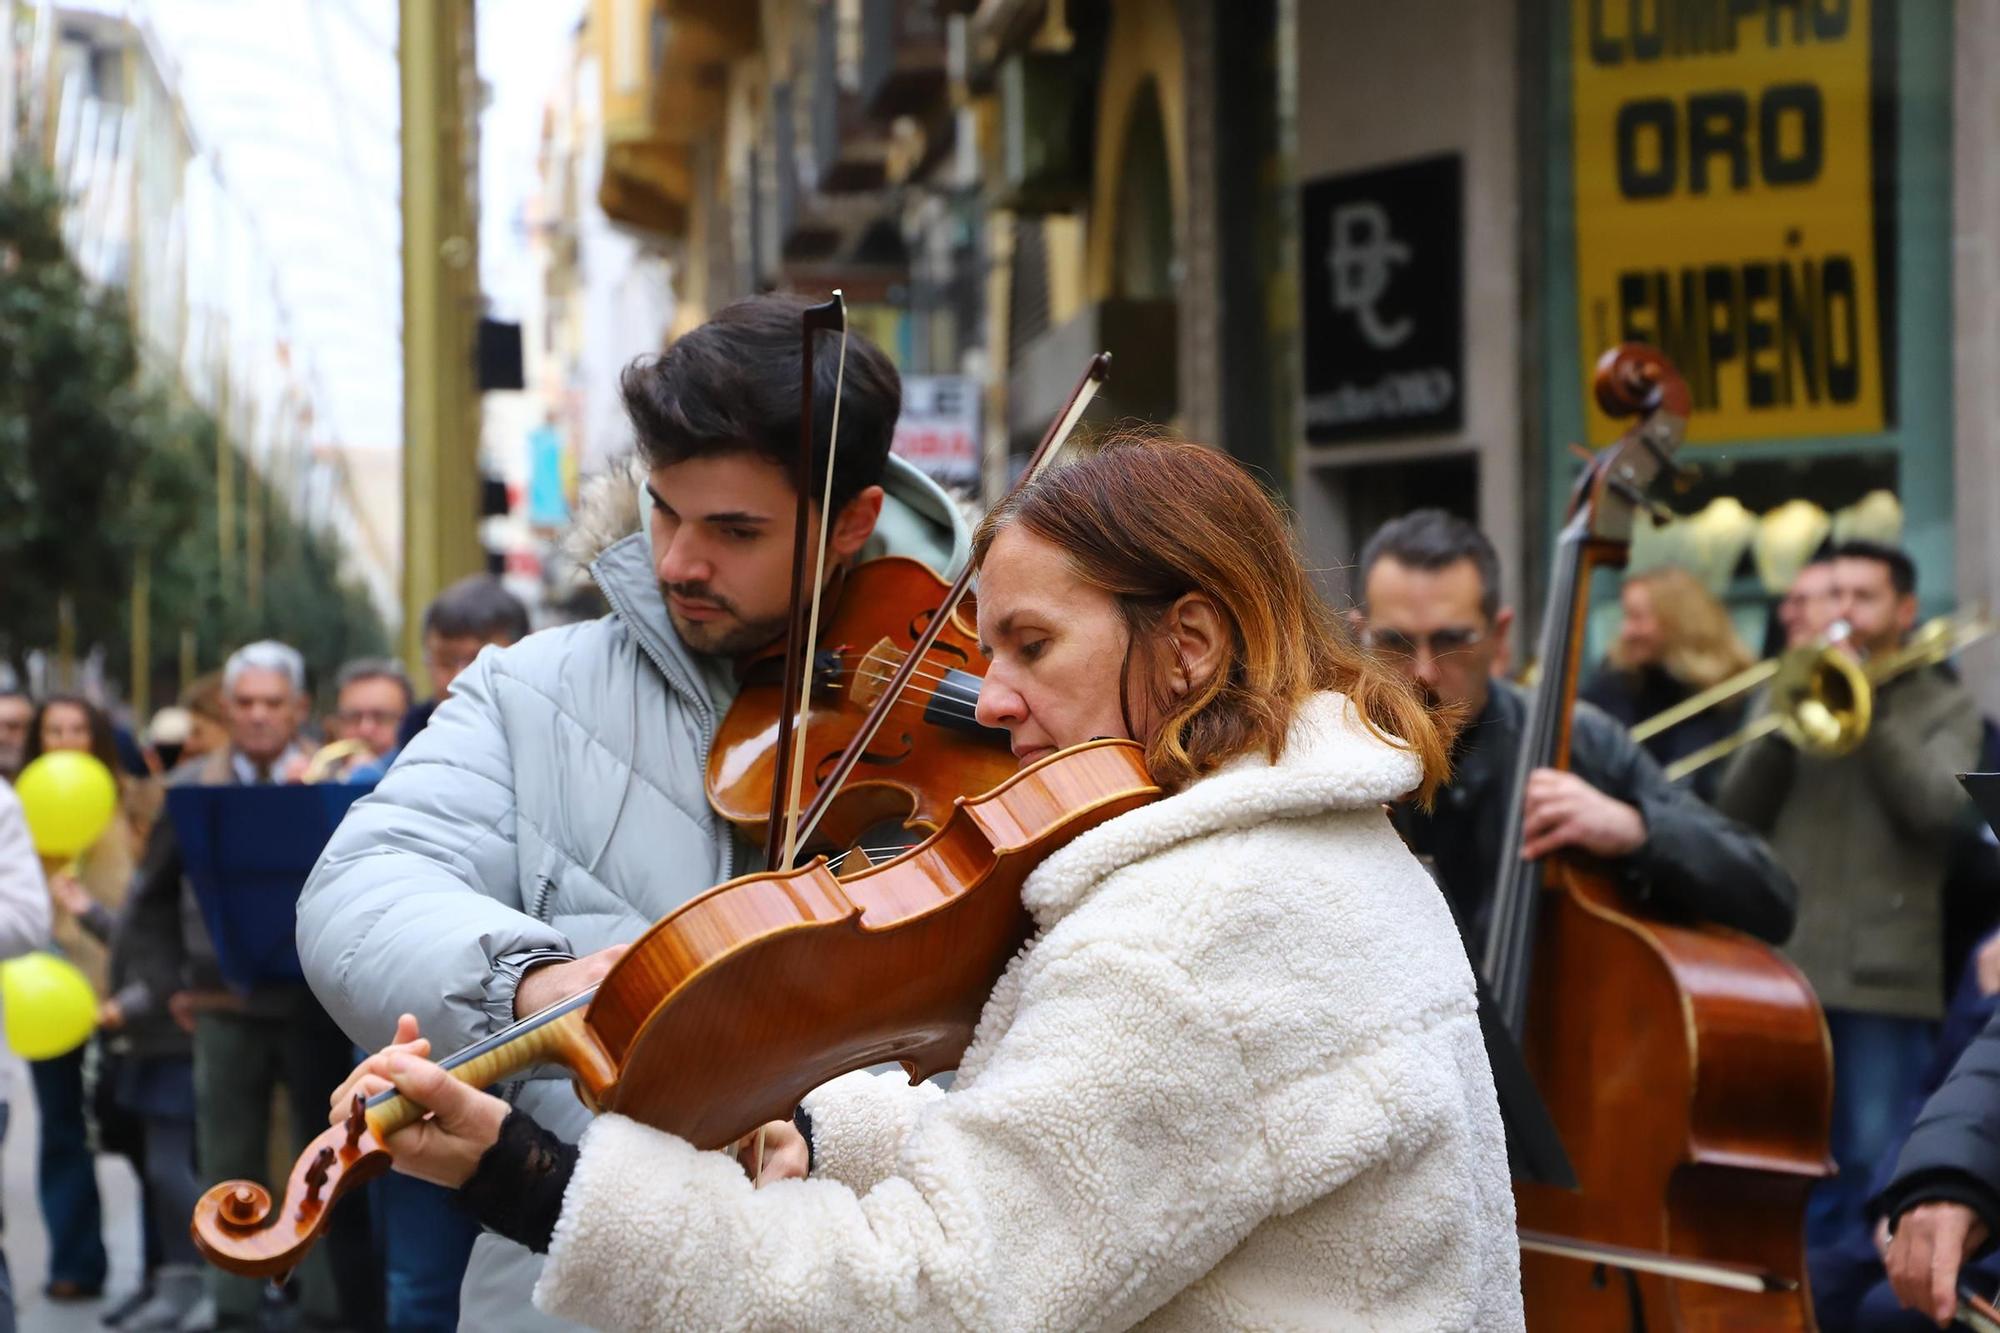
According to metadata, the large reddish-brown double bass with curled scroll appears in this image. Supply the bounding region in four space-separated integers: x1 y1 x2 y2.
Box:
1482 344 1832 1333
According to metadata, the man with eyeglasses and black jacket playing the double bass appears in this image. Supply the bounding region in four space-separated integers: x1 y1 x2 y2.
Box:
1354 508 1798 957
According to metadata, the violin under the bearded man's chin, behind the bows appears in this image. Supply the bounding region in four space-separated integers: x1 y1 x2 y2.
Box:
708 556 1014 849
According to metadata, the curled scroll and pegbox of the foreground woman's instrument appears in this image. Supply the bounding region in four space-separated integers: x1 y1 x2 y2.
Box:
188 1093 390 1279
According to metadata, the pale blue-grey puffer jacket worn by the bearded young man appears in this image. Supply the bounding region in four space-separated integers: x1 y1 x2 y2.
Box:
298 458 970 1333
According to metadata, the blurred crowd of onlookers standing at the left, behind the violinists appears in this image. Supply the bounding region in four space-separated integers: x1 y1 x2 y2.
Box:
0 576 528 1333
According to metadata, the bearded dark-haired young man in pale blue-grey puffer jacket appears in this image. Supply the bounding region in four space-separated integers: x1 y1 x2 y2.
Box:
298 296 968 1329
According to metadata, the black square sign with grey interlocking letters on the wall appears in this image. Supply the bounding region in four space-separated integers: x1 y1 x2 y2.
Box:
1298 154 1466 440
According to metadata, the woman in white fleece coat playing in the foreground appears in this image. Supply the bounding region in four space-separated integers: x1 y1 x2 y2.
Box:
334 440 1522 1329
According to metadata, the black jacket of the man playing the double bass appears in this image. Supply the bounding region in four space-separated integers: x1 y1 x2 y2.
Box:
1396 683 1798 959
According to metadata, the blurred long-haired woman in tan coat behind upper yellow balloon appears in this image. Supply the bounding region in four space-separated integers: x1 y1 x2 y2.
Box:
24 695 132 1301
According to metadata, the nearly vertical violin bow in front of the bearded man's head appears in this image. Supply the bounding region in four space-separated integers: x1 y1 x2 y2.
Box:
764 288 848 871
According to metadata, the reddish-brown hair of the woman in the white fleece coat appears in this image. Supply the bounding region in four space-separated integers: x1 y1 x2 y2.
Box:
972 436 1450 803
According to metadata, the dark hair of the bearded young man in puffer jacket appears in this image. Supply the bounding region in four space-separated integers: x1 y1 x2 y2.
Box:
618 294 902 514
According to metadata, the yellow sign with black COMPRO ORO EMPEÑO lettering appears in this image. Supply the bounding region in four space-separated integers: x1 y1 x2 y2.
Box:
1570 0 1888 444
